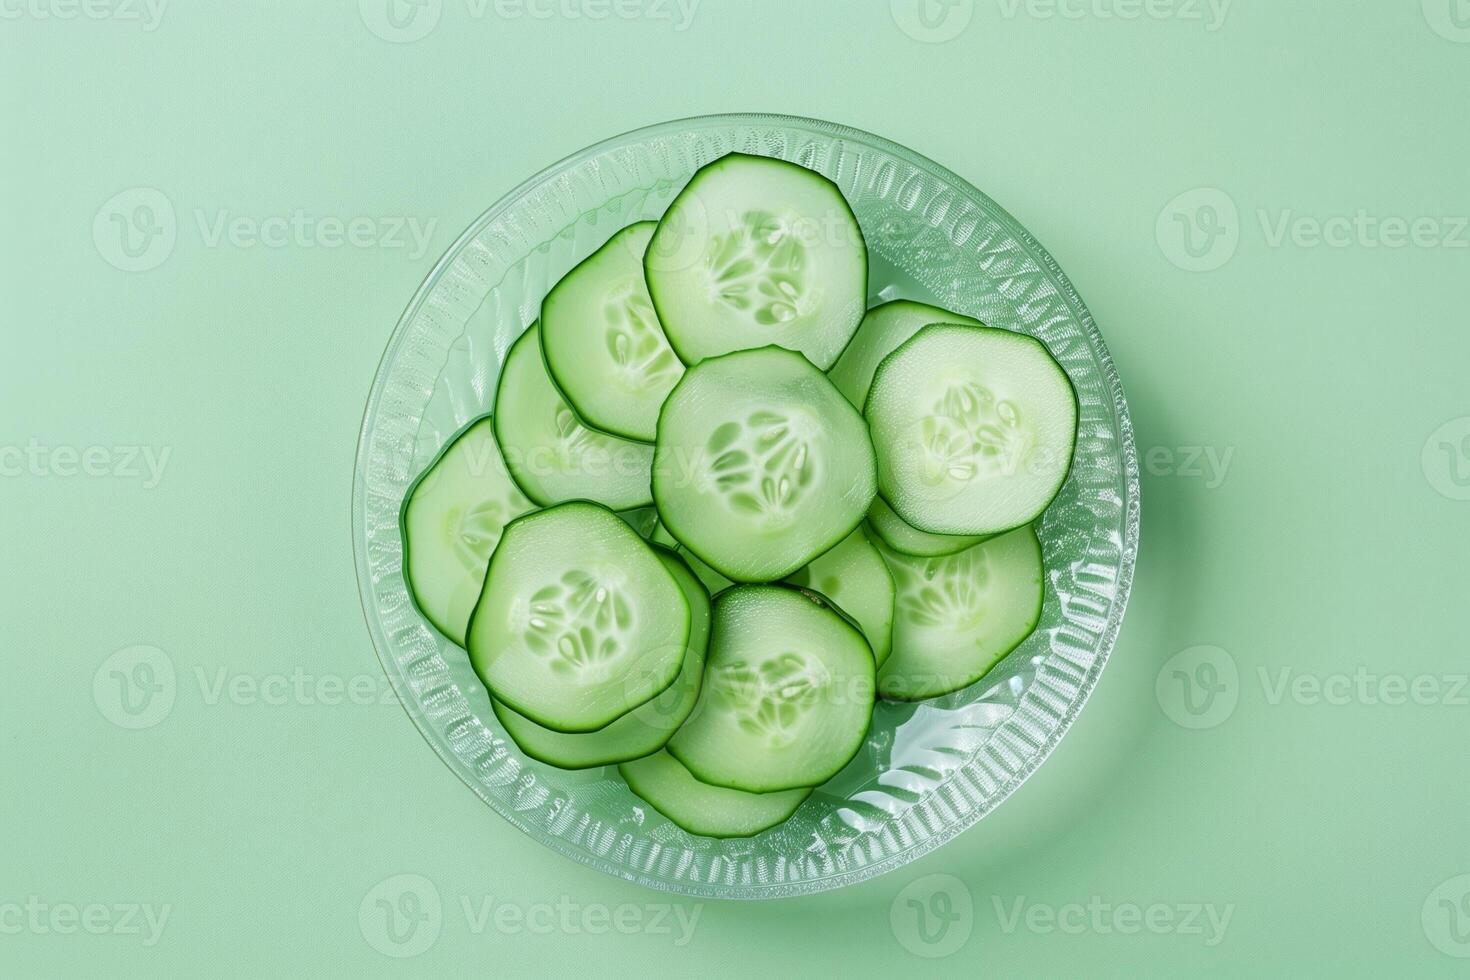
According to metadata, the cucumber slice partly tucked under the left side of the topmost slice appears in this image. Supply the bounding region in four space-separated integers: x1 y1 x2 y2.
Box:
541 222 684 442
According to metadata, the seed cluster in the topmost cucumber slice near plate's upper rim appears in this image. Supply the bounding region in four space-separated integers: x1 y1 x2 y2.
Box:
706 212 807 326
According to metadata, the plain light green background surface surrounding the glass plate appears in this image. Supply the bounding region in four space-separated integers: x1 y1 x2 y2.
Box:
0 0 1470 977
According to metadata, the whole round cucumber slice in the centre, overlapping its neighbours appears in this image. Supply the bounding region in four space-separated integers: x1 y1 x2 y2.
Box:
653 347 875 582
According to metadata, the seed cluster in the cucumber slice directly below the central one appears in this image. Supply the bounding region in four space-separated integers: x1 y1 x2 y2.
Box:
710 651 831 748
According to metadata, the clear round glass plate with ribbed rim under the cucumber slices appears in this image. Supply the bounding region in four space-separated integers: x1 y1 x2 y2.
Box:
353 115 1139 899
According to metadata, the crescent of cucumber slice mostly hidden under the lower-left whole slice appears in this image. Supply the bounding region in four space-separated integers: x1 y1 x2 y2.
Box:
491 550 710 768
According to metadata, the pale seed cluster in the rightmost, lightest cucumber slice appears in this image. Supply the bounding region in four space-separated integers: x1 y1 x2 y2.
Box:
919 382 1030 486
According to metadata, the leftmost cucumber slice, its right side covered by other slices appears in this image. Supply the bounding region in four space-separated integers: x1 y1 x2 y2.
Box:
398 416 535 646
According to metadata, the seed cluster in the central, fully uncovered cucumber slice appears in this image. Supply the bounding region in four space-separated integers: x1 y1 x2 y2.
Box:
704 408 817 525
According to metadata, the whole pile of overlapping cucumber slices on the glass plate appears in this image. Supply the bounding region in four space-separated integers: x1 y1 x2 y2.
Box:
401 154 1078 837
